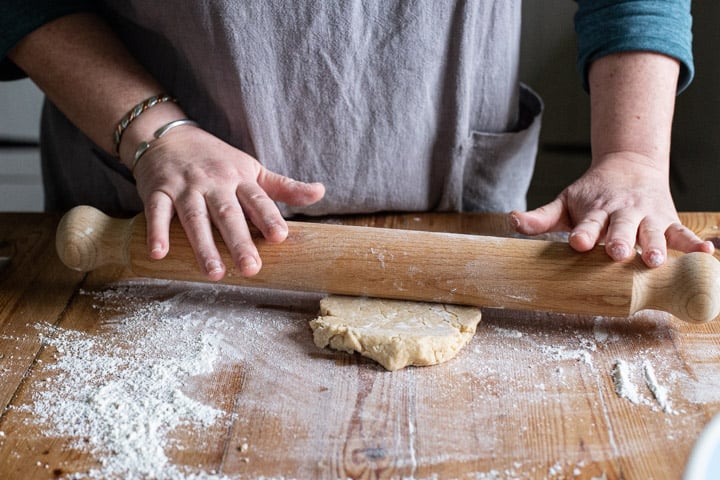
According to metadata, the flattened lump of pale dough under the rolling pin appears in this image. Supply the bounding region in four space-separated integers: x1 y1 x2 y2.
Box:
310 295 480 370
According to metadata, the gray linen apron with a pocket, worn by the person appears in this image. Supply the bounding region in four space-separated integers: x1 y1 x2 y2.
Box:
42 0 542 216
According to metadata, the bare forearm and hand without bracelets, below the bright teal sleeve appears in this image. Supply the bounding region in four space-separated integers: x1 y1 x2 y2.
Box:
513 52 713 267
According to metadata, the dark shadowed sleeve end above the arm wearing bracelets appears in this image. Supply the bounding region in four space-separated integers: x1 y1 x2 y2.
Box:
0 0 95 80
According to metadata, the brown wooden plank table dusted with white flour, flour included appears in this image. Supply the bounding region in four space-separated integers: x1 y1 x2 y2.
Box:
0 213 720 479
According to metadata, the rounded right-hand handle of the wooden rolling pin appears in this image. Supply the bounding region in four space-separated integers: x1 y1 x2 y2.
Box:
631 252 720 323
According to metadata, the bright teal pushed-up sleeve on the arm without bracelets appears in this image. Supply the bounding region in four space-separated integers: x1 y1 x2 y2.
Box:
575 0 695 93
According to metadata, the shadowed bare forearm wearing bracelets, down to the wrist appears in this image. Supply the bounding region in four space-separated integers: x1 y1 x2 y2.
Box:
9 14 183 165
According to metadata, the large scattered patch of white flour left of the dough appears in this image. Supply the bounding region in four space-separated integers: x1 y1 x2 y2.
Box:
15 285 242 480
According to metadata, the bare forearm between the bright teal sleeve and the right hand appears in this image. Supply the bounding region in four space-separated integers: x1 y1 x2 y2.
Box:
589 52 679 170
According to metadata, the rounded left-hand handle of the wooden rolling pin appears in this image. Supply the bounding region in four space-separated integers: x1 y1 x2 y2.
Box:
55 205 134 272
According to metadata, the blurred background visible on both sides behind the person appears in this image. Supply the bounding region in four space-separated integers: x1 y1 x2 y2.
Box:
0 0 720 211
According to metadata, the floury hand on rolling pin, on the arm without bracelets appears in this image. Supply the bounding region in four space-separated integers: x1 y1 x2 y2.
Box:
511 153 714 267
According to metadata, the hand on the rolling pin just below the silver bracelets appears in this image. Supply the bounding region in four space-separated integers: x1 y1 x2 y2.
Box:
134 126 325 281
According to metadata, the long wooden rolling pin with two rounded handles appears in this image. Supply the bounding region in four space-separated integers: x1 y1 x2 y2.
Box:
56 206 720 322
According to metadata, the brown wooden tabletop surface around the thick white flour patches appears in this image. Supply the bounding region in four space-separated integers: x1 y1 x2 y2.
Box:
0 213 720 479
